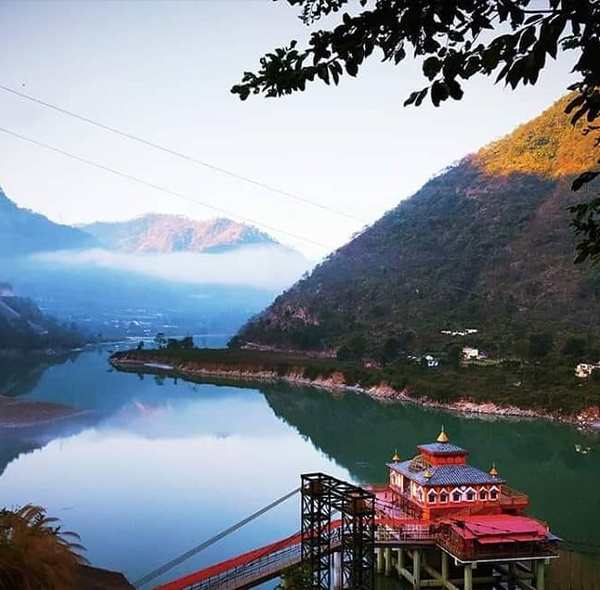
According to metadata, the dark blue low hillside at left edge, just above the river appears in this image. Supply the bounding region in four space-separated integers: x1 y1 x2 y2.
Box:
0 283 85 352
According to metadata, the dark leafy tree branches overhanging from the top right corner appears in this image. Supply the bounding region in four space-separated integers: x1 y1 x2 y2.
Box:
232 0 600 262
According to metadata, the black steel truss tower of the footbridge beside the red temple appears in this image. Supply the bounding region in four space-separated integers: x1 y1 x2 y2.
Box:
301 473 375 590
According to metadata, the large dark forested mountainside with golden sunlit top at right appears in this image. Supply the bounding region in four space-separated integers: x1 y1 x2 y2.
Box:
238 97 600 355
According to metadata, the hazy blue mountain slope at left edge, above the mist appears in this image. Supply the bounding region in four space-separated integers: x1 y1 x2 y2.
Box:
0 188 95 256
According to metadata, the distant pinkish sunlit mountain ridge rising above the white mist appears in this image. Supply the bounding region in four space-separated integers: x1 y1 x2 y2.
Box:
81 214 277 254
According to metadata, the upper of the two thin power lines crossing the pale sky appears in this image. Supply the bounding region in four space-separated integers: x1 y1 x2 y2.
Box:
0 84 370 224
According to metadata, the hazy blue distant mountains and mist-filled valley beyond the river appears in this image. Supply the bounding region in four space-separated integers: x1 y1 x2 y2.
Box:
0 184 312 348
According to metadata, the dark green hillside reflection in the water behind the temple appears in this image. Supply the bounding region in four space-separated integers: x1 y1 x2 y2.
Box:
263 385 600 545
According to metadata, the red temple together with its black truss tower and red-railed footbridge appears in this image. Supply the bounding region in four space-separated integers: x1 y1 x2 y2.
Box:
150 428 559 590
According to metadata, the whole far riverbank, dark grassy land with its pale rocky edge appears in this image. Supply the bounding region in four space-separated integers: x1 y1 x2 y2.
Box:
110 349 600 429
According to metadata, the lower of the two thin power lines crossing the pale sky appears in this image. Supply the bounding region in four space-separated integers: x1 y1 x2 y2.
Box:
0 127 334 250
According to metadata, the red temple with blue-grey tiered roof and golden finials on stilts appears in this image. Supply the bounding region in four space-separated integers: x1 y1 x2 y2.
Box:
369 427 559 590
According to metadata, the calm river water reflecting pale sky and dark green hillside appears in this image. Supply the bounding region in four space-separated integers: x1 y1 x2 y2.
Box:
0 341 600 586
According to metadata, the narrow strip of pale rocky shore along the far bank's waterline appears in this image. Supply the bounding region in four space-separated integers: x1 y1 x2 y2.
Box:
110 353 600 430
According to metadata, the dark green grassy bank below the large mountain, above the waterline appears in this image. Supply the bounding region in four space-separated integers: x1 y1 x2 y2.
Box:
111 349 600 420
